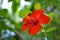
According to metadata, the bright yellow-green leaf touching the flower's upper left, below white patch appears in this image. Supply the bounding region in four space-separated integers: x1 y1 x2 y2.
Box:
19 5 31 18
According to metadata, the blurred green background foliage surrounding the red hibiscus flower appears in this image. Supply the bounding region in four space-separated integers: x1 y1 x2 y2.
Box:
0 0 60 40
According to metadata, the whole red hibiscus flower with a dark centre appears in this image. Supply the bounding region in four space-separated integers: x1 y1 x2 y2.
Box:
22 10 50 35
